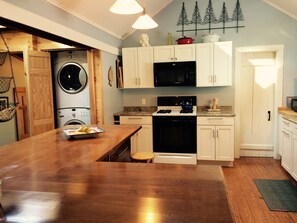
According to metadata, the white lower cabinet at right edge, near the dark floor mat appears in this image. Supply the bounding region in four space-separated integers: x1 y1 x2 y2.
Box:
279 116 297 180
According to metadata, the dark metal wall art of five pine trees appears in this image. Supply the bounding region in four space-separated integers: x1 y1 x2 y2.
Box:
177 0 244 36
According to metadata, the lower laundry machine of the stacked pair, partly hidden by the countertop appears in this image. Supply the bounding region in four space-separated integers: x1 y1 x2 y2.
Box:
57 108 91 127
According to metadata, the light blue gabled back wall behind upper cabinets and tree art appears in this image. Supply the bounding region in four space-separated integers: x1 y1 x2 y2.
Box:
124 0 297 106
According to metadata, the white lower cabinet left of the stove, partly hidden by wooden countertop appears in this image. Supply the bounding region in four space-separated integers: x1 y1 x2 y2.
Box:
120 116 153 153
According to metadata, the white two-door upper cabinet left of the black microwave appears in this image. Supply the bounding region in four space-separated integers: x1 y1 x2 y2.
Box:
122 47 154 88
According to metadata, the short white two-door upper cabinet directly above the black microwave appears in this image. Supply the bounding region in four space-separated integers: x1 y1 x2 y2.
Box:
154 44 196 62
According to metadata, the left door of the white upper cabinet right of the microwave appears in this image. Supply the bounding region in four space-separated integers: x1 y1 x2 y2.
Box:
196 43 213 87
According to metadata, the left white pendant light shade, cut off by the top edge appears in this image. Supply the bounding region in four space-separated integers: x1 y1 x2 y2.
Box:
109 0 143 15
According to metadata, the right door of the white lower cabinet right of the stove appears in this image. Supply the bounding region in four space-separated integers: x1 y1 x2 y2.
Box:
216 126 234 161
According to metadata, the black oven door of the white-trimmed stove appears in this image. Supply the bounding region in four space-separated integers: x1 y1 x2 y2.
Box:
153 116 197 154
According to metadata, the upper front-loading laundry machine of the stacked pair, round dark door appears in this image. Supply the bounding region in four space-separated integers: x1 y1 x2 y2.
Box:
53 51 90 109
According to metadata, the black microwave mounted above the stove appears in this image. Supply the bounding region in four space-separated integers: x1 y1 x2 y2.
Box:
154 61 196 87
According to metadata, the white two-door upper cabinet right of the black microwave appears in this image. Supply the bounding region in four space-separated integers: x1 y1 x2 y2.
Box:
196 41 232 87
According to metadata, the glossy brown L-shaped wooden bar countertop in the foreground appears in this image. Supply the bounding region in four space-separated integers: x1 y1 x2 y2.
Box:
0 125 233 223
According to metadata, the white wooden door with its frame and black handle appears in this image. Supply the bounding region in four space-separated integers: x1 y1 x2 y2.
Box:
234 45 284 158
